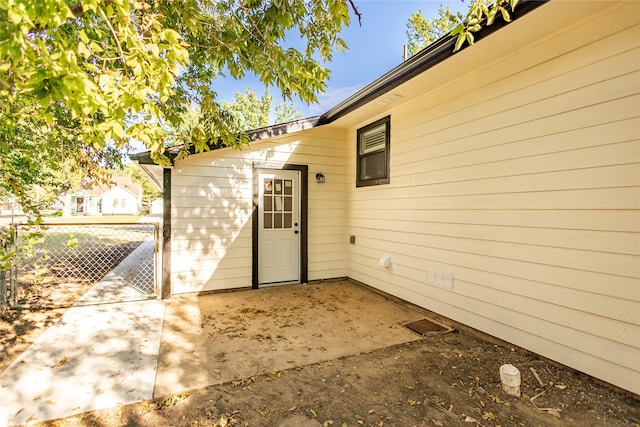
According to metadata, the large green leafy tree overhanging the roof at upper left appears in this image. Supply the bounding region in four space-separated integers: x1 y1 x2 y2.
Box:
0 0 357 274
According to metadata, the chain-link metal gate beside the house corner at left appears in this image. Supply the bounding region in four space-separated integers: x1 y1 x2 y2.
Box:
8 223 160 307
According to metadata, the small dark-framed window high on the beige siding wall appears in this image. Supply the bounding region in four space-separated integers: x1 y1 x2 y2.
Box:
356 116 391 187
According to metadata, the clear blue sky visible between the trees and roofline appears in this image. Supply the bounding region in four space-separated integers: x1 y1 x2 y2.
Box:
215 0 469 117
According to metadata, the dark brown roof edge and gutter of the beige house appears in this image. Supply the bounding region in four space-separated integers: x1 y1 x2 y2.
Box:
129 0 550 164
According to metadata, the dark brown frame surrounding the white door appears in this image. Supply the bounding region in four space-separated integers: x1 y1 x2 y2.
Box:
251 162 309 289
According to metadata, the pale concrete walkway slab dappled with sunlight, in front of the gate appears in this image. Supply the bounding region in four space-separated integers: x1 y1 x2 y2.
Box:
0 300 165 426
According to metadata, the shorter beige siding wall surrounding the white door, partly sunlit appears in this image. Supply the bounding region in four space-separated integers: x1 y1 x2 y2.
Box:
171 129 346 293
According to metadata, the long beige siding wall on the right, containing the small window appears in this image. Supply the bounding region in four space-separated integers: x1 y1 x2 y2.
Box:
346 2 640 393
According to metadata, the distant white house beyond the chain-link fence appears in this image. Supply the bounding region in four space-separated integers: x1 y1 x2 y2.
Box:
71 176 142 215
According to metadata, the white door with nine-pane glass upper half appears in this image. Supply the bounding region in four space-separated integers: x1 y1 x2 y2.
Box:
258 170 301 284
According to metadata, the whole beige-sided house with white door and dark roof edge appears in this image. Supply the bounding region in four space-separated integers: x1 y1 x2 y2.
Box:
132 0 640 393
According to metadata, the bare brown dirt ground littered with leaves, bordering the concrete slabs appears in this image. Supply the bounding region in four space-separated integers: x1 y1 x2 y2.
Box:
0 282 640 427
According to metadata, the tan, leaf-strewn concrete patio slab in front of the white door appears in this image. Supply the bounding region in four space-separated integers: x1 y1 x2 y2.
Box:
154 281 423 397
